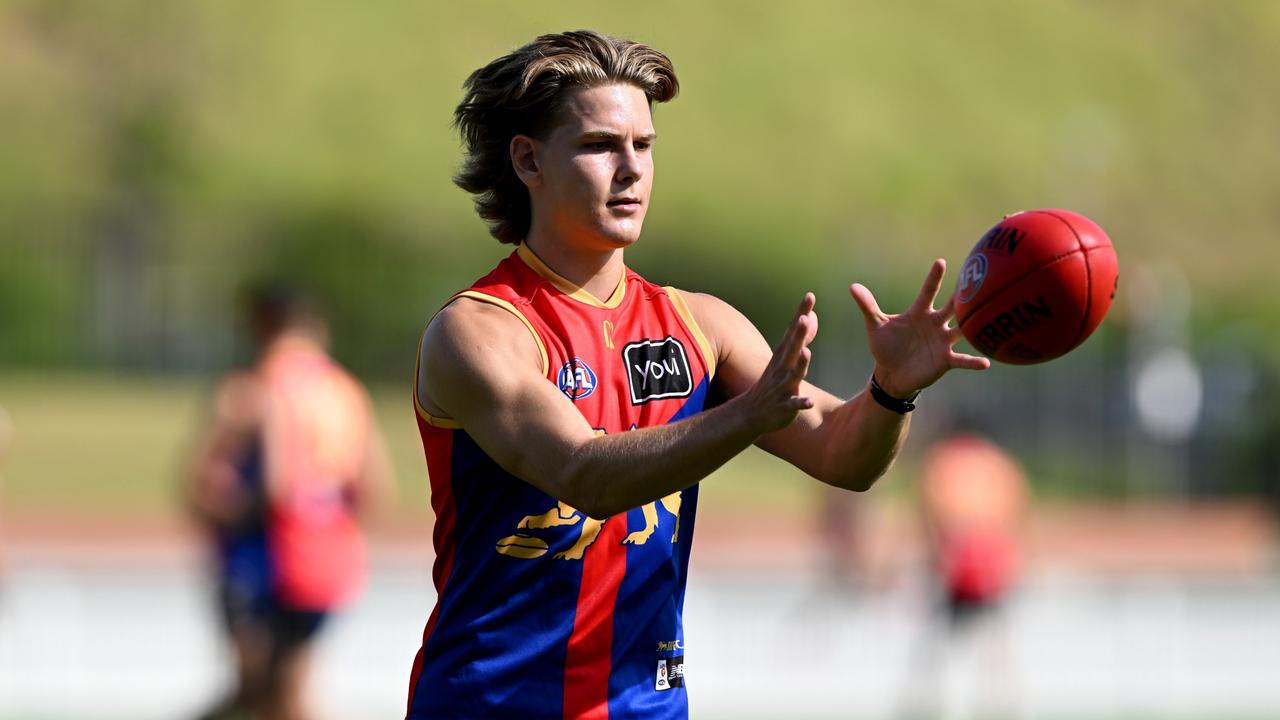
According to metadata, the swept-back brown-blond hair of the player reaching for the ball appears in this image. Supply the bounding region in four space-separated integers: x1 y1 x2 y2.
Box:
453 29 680 243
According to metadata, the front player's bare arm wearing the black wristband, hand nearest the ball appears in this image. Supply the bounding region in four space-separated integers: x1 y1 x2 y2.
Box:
686 260 989 491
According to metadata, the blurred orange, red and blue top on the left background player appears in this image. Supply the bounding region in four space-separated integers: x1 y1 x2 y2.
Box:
218 338 374 611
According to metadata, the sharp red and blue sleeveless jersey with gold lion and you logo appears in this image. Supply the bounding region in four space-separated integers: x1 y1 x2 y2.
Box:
408 245 714 720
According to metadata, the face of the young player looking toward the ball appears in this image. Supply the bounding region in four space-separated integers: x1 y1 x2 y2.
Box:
531 85 655 250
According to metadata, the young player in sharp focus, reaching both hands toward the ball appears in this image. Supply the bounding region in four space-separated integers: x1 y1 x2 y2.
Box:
408 32 987 719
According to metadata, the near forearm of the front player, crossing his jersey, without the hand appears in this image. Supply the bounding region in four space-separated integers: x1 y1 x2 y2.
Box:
554 398 763 518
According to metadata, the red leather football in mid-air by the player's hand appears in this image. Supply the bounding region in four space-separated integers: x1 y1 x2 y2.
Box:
955 210 1119 365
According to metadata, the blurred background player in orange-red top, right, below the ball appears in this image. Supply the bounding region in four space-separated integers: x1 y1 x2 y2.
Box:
904 415 1029 720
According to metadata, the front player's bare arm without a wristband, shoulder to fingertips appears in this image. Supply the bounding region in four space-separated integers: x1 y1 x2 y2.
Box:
419 299 813 518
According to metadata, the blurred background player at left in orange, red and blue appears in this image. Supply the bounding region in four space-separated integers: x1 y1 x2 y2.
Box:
187 284 390 720
